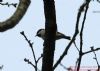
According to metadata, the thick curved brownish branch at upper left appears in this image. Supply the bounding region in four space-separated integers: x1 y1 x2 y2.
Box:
0 0 31 32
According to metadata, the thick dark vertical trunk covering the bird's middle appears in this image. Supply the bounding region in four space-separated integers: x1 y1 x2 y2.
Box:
42 0 57 71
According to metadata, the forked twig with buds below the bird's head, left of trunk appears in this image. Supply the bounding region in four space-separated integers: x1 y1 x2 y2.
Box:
20 31 43 71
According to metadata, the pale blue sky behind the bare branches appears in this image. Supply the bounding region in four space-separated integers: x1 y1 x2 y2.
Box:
0 0 100 71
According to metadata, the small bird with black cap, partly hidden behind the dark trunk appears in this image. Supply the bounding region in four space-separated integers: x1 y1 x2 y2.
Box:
36 29 71 40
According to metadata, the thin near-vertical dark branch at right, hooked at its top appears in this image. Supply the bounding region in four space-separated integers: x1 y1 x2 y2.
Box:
77 0 90 71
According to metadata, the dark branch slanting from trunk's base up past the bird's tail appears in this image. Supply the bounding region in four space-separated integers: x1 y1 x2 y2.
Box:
53 0 89 69
